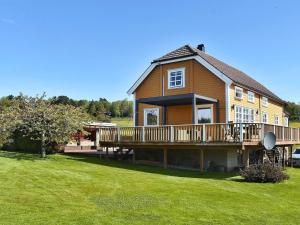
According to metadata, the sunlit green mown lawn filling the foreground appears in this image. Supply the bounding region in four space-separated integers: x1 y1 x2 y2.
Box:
0 151 300 225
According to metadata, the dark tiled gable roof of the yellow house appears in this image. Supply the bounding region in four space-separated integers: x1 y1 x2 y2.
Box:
129 45 285 103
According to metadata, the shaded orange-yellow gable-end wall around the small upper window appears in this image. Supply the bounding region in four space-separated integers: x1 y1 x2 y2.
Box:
135 60 226 126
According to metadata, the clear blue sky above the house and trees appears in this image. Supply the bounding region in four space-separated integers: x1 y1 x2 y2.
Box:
0 0 300 102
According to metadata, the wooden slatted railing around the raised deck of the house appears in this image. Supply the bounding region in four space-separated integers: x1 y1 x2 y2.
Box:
100 123 300 143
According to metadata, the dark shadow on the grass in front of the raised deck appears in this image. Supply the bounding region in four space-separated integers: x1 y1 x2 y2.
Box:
65 154 237 180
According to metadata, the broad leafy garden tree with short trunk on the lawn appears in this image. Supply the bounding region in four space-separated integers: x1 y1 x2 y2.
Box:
3 95 89 157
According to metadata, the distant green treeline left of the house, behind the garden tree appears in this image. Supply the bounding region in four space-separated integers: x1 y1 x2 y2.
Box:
0 95 133 121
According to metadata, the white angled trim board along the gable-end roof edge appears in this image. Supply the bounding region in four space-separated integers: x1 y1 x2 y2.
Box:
127 56 232 95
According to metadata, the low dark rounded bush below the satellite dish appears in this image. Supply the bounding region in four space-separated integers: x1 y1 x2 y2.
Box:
240 163 289 183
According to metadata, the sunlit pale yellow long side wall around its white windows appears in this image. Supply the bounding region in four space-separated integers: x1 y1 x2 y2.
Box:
230 85 284 125
